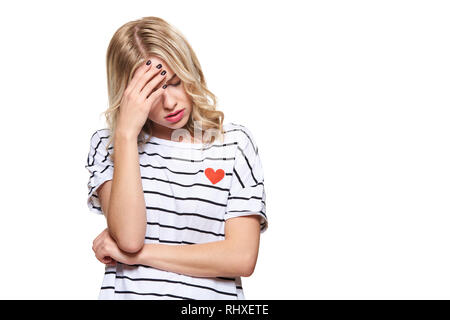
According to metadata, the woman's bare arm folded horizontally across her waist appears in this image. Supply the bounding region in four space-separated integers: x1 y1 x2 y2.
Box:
93 215 260 277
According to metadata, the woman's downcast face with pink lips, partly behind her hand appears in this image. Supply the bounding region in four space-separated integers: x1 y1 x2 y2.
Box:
148 56 192 140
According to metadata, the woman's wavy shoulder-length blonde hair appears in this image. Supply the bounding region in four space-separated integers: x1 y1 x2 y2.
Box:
102 17 224 161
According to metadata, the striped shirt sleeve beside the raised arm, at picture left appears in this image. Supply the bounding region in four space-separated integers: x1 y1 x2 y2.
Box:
85 130 114 214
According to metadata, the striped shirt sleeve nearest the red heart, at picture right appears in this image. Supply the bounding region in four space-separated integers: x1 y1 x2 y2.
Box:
224 127 268 233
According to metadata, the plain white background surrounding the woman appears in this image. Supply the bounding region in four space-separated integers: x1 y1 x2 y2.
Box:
0 1 450 299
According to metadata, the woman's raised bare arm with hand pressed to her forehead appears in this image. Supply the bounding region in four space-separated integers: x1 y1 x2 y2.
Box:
98 59 166 253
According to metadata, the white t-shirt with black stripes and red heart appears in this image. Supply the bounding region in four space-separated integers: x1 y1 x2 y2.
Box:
86 123 268 300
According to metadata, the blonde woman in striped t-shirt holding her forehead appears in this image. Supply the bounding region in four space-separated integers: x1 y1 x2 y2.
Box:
86 17 268 299
